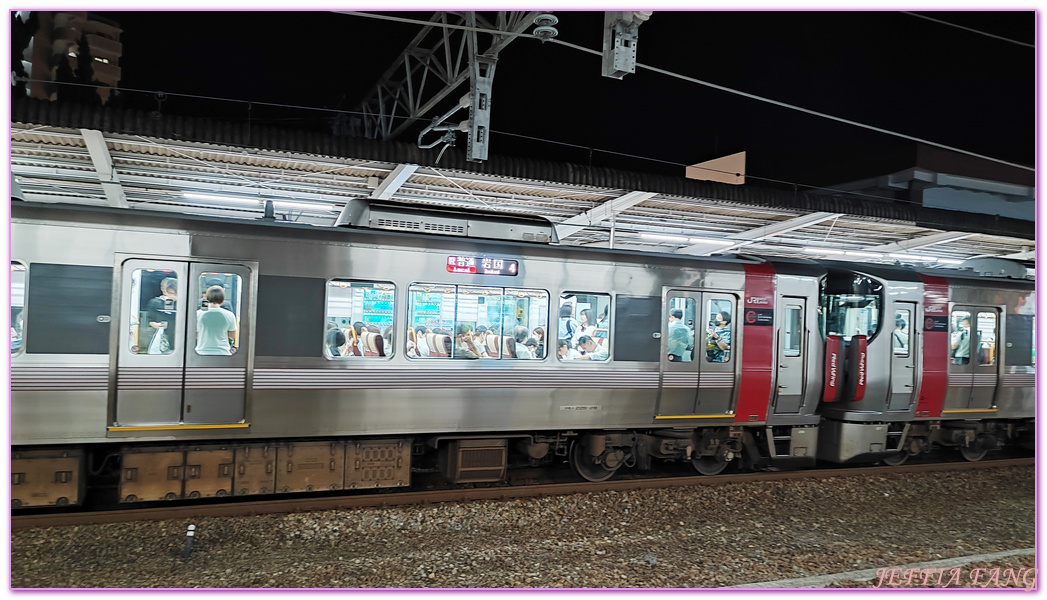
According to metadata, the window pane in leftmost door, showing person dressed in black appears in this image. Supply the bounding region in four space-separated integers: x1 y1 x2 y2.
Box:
128 269 179 355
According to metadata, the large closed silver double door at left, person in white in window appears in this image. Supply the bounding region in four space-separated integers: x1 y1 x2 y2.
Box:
114 259 250 427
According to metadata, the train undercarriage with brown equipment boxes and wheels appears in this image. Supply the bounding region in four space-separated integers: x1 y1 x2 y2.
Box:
12 419 1034 509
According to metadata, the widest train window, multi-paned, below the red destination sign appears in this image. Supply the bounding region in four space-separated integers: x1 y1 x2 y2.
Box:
407 284 549 359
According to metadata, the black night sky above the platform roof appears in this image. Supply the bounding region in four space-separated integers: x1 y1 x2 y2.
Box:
75 10 1035 185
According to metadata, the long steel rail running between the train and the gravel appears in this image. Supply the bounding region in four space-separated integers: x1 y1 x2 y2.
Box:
12 458 1035 530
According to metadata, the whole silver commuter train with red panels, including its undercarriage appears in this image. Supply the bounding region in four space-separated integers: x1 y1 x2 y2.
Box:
10 202 1035 508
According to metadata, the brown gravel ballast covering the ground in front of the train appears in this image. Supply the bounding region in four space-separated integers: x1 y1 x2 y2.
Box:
10 467 1035 588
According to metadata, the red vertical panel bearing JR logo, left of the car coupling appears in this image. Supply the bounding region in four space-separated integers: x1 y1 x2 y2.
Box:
734 263 775 423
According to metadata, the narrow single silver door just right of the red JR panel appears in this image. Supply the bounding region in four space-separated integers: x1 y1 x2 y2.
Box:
774 296 807 415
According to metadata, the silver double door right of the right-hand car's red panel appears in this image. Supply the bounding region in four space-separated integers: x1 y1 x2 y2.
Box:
943 306 1000 413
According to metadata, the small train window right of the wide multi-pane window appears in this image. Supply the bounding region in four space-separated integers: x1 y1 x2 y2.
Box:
556 293 610 361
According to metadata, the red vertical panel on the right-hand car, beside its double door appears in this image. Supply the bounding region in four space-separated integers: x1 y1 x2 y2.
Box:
916 275 949 417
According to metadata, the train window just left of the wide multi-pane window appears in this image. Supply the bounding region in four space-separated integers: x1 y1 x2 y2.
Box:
324 280 396 359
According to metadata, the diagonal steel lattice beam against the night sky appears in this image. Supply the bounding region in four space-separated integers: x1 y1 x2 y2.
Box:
347 10 538 139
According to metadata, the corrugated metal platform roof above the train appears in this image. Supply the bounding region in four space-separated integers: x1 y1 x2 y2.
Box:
12 99 1034 272
